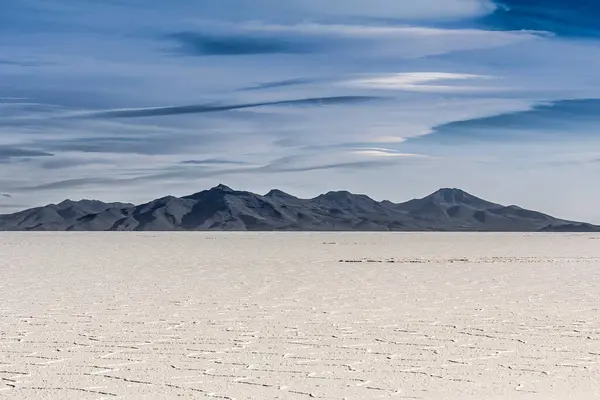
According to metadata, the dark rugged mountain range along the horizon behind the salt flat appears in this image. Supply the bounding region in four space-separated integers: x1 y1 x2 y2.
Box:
0 185 600 232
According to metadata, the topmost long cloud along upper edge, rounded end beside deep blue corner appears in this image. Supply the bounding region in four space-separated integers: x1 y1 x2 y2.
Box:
0 0 496 30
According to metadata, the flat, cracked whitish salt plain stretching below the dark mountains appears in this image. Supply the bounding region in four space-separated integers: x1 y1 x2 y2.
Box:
0 233 600 400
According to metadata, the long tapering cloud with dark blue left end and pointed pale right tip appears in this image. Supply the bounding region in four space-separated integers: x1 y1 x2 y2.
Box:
179 21 539 62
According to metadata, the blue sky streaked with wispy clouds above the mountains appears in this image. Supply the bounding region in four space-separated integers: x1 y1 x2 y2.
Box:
0 0 600 223
